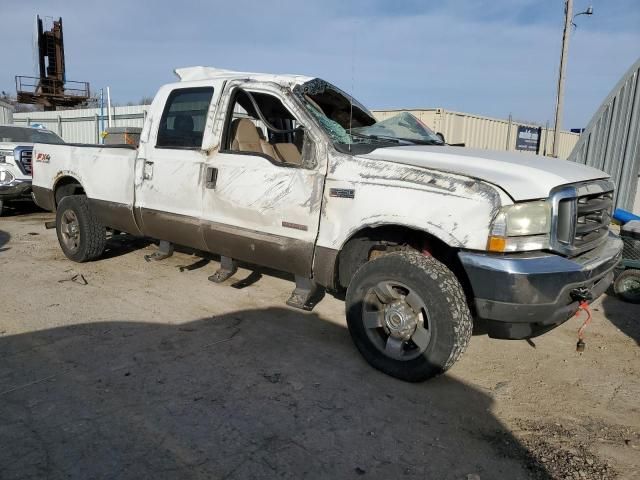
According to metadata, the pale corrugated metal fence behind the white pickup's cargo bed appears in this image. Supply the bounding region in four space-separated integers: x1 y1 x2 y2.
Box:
13 105 149 143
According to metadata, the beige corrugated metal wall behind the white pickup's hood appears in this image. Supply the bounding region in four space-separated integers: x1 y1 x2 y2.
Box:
373 108 580 158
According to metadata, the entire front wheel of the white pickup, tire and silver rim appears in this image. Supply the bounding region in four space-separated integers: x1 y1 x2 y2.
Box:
346 252 473 382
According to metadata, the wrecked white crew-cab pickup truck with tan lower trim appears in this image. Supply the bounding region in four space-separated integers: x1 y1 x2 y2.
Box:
33 67 622 381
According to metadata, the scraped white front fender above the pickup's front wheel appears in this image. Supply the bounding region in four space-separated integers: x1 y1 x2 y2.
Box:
318 152 513 250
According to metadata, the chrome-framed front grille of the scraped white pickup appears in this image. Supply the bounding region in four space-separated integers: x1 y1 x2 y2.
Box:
551 181 613 255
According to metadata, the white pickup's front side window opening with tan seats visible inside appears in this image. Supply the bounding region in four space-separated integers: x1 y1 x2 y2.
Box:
224 89 304 166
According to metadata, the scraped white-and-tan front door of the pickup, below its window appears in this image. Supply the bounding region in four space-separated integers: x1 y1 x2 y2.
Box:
203 149 324 276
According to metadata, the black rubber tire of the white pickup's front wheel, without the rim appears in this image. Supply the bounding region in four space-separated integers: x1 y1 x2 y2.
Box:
346 251 473 382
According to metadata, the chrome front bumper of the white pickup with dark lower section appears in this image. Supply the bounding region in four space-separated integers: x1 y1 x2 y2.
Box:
459 233 622 339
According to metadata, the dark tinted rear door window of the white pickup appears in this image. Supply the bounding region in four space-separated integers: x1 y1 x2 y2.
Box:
156 87 213 148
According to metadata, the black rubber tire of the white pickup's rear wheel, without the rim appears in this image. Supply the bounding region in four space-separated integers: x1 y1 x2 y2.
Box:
56 195 107 263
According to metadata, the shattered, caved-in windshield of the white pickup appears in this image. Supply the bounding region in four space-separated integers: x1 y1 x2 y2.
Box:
293 78 444 153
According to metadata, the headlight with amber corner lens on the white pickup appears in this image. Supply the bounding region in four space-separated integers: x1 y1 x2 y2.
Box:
487 201 551 252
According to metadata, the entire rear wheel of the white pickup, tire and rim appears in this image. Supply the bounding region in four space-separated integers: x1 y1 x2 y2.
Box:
56 195 107 263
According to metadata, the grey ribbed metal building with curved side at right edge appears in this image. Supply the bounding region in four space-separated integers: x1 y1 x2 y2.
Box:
569 59 640 210
